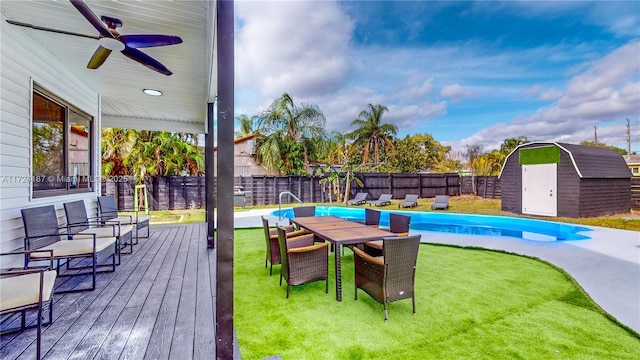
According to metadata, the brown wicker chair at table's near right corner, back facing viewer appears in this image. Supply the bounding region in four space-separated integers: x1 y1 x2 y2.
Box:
353 235 420 321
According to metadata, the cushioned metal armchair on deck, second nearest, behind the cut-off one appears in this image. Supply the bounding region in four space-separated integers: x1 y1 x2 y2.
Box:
21 205 118 293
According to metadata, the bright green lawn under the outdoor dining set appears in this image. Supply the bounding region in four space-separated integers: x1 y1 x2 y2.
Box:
234 229 640 359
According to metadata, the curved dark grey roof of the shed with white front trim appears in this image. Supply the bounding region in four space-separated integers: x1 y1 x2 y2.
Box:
500 142 631 179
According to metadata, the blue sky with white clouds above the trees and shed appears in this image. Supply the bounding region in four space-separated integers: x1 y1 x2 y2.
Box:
235 0 640 152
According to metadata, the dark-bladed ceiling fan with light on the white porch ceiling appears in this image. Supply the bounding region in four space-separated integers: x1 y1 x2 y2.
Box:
7 0 182 75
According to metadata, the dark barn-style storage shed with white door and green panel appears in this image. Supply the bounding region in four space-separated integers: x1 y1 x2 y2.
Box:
500 142 631 218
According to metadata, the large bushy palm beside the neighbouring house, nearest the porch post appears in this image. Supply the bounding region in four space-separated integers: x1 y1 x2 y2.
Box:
256 93 326 174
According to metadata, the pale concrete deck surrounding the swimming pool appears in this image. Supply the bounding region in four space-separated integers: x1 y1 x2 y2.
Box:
228 209 640 332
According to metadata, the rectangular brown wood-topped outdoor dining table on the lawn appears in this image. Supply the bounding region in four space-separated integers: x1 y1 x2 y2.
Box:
291 216 397 301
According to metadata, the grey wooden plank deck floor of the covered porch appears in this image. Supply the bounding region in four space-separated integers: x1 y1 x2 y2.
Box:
0 223 216 360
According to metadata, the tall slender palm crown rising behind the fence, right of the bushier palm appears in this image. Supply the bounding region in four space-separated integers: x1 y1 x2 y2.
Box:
349 104 398 165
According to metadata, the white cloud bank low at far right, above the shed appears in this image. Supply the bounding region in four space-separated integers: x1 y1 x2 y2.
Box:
453 41 640 152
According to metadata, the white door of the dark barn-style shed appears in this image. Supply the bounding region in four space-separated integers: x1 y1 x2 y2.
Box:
522 164 558 216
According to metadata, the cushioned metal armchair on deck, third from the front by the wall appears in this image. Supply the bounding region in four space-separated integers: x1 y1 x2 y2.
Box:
64 200 133 265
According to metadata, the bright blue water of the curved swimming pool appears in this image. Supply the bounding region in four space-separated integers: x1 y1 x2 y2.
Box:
273 206 591 241
